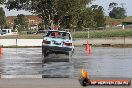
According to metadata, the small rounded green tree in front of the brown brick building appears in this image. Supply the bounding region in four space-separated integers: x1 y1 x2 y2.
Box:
14 14 28 33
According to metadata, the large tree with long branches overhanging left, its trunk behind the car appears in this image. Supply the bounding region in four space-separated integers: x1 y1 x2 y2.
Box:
6 0 57 28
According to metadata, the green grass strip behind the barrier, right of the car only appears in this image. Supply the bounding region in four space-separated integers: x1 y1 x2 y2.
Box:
73 29 132 38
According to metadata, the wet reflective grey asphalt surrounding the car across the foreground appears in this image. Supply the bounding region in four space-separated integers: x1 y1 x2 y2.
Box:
0 47 132 78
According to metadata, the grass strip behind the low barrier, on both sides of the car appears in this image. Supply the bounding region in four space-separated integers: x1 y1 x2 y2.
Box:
0 29 132 39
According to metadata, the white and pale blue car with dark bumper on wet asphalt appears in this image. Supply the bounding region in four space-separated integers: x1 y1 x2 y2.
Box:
42 30 74 57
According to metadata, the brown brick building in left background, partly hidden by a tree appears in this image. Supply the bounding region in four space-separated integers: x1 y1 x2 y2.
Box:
6 15 42 29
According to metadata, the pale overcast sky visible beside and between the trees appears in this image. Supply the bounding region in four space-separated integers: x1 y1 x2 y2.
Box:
1 0 132 16
